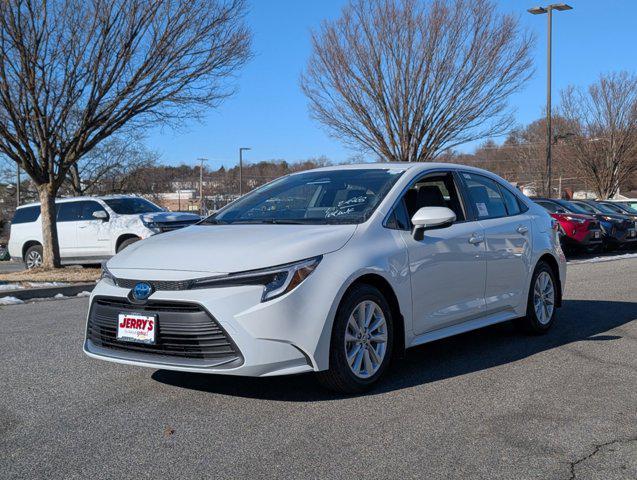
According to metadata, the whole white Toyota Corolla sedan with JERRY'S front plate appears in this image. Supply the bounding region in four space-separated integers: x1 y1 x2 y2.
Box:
84 163 566 392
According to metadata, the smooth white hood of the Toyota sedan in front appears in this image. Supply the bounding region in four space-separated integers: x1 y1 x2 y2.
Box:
108 225 356 273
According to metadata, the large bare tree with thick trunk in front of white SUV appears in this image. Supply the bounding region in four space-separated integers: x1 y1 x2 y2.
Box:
0 0 250 267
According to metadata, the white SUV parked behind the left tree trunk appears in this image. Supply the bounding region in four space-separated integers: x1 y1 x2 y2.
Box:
9 195 200 268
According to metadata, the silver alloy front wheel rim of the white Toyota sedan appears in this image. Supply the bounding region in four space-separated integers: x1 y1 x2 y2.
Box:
345 300 387 378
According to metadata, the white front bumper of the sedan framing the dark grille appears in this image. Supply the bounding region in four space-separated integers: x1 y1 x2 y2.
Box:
84 262 340 376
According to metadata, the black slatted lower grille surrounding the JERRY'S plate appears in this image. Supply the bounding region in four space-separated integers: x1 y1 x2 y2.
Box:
86 297 242 363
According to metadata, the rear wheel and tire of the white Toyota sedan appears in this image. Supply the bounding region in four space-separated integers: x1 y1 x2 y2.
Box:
517 261 558 334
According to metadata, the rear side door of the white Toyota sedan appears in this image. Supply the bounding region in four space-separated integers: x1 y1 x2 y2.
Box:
462 172 533 314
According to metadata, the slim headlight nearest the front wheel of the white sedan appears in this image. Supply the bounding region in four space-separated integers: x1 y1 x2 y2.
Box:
191 256 323 302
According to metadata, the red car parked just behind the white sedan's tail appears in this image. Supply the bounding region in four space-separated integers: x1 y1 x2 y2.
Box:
535 200 602 252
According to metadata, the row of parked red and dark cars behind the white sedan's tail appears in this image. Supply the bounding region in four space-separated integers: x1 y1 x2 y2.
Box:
533 198 637 253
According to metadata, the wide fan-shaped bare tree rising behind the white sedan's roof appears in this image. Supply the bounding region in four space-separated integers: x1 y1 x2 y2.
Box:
301 0 534 161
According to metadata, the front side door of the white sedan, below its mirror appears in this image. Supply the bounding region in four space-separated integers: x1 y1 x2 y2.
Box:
402 172 486 335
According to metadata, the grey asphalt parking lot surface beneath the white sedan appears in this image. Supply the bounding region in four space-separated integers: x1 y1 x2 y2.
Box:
0 258 637 480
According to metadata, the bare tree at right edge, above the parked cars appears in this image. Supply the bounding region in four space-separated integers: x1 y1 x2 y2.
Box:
561 72 637 198
